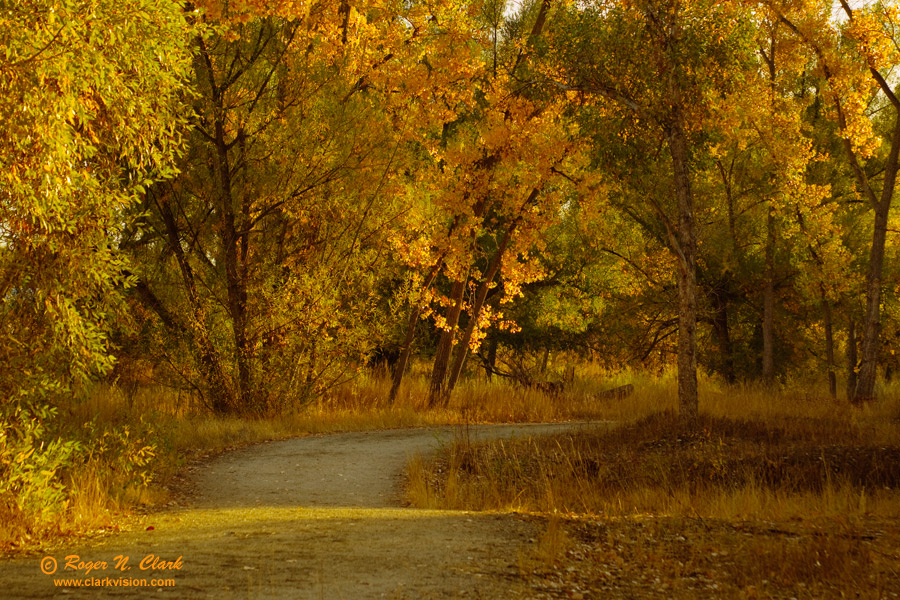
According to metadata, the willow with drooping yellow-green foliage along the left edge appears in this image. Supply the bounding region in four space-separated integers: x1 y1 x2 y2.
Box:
0 0 189 520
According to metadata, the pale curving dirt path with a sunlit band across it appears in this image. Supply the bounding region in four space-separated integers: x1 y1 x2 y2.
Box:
0 424 604 599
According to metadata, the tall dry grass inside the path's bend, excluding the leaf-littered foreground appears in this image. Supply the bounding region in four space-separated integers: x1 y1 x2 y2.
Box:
411 382 900 518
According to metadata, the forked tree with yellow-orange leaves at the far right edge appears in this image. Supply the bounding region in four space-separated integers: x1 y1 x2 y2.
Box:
766 0 900 401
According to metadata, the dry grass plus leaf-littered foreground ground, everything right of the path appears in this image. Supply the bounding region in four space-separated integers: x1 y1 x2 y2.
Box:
408 381 900 598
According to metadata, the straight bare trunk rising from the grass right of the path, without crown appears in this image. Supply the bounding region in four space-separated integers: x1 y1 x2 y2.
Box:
668 110 699 419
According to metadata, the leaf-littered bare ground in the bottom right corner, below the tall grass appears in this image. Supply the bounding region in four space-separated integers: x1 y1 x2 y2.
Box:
522 516 900 600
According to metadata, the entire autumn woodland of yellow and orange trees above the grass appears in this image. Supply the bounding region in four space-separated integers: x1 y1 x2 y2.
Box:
0 0 900 552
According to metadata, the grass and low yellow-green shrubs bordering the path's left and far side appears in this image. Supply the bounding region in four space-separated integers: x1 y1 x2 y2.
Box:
0 360 636 552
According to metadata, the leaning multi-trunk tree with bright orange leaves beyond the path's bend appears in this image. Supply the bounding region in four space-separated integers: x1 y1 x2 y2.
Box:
391 2 577 404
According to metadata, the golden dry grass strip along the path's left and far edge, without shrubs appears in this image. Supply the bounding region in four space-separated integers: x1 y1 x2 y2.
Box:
0 371 632 552
